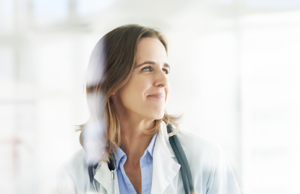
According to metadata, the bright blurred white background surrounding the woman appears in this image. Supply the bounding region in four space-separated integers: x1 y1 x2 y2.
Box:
0 0 300 194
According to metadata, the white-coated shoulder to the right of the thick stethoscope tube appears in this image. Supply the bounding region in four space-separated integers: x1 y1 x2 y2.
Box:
177 131 240 194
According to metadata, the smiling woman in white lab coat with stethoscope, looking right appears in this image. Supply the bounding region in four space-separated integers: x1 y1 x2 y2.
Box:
58 25 240 194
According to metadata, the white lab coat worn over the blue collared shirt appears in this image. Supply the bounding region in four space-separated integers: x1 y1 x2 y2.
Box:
57 122 240 194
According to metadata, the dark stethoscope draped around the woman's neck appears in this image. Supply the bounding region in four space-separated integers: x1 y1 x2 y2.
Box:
88 124 194 194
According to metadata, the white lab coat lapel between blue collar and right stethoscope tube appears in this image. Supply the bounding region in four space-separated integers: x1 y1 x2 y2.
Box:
151 122 180 194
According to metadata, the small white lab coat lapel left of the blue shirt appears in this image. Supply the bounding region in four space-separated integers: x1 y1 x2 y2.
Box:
94 161 113 194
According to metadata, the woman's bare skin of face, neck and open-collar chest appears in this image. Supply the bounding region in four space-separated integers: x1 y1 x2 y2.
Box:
112 38 170 193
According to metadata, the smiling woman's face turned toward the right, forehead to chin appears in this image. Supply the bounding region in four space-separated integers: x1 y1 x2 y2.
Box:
118 38 170 120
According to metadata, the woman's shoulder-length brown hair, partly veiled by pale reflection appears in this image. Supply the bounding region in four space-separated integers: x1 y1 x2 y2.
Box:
79 25 179 161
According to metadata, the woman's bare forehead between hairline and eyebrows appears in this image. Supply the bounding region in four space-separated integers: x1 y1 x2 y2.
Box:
135 38 167 62
